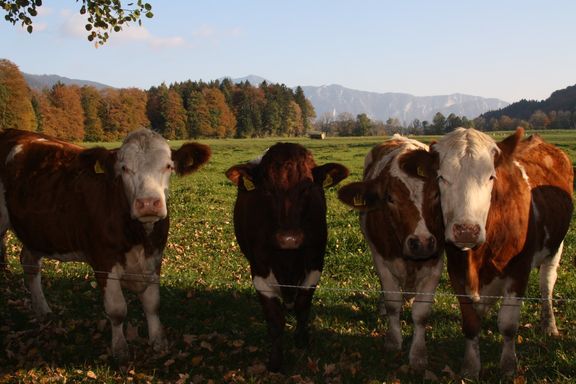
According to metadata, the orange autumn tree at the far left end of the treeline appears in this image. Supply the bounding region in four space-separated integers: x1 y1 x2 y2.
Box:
0 59 36 131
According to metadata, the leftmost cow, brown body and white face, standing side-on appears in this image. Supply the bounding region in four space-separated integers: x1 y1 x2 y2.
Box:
0 128 210 362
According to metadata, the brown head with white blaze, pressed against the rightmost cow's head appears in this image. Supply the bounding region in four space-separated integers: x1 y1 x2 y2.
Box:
338 143 443 260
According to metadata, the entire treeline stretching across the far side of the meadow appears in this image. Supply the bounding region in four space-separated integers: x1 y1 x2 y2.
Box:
0 60 576 142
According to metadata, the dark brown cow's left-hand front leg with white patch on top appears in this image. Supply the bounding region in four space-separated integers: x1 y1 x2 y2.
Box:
252 271 286 372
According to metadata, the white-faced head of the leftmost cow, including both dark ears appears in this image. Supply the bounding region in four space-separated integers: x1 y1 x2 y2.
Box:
83 129 210 223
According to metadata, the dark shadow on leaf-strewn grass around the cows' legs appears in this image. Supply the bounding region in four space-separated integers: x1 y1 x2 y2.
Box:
0 273 576 383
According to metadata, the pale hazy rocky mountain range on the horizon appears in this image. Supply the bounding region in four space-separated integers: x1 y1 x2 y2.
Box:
302 85 509 123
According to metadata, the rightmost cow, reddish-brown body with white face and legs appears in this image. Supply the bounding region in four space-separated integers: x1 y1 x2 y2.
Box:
432 128 574 377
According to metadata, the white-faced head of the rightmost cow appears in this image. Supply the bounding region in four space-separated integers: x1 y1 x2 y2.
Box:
431 128 524 250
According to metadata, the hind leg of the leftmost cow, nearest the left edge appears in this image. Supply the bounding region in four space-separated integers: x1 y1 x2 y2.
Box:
20 246 52 318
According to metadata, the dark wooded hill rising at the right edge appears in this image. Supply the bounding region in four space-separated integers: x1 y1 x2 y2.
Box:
482 85 576 120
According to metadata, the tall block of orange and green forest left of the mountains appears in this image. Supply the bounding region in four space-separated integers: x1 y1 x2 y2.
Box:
0 60 316 141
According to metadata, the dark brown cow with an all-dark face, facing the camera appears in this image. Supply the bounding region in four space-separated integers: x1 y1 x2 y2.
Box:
226 143 348 372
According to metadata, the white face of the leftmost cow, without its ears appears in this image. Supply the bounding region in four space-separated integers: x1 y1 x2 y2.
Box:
116 129 174 223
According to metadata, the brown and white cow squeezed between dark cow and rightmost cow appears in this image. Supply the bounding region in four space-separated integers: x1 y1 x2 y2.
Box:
338 135 444 371
